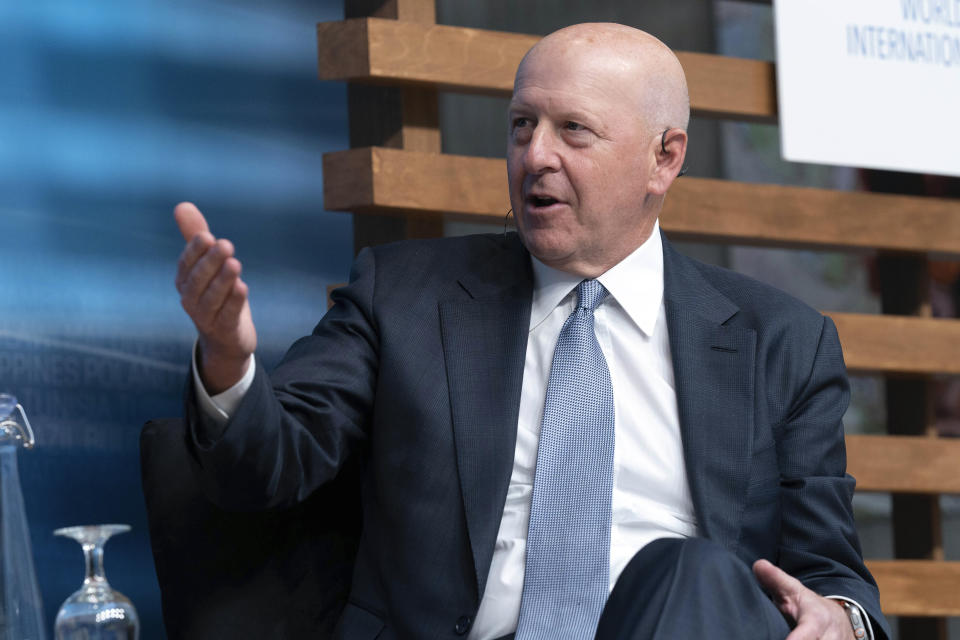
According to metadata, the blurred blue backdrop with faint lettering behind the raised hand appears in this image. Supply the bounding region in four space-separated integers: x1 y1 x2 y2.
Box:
0 0 352 640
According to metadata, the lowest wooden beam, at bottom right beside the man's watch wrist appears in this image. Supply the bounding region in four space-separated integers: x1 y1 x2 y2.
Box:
867 560 960 616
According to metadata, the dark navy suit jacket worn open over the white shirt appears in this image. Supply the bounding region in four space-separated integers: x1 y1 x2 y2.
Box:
188 234 886 640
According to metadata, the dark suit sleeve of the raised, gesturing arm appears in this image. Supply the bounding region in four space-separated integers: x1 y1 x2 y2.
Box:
185 245 378 510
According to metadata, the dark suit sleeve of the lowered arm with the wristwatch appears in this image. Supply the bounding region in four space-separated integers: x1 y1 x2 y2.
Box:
775 317 889 640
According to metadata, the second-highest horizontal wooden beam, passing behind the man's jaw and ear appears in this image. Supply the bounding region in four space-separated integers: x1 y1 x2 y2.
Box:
323 148 960 255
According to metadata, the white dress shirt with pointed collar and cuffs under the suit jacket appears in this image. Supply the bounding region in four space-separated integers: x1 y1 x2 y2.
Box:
193 222 873 640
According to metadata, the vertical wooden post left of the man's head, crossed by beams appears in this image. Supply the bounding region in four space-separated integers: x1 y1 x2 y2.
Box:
344 0 443 251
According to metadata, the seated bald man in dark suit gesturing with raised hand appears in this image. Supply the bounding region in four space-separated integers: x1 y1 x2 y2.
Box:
176 24 886 640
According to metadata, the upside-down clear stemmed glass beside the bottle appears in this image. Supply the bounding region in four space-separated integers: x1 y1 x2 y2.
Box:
53 524 140 640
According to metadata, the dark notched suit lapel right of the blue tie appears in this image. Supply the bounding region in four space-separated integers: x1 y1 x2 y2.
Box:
663 238 756 550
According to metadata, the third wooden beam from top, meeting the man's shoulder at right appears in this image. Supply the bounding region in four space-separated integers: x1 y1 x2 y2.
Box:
827 312 960 378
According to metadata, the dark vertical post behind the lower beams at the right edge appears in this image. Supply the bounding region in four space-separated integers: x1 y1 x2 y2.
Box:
877 255 947 640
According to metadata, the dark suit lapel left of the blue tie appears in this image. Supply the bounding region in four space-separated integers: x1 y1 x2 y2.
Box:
440 236 533 594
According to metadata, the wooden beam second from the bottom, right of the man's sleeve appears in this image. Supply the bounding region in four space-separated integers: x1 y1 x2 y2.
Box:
847 435 960 496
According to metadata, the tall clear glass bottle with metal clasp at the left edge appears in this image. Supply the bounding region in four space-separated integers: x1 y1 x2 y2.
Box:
0 393 46 640
